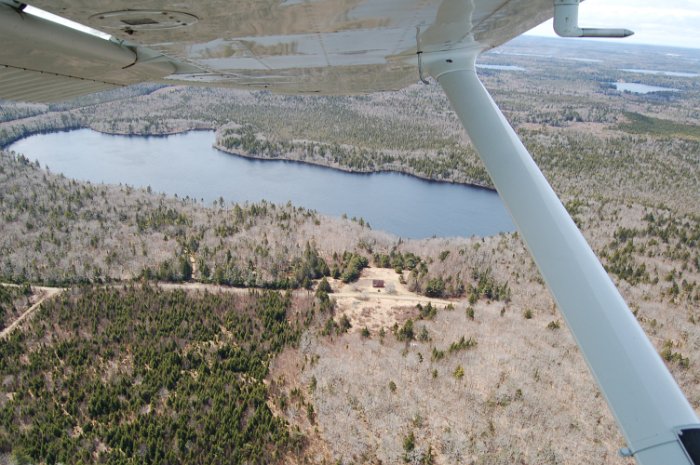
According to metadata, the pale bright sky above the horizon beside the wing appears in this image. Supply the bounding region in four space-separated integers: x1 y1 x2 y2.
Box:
527 0 700 48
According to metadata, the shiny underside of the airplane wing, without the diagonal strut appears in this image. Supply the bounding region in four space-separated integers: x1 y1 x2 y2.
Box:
0 0 553 101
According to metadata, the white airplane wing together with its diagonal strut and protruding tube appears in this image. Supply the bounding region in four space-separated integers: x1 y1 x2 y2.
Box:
0 0 700 465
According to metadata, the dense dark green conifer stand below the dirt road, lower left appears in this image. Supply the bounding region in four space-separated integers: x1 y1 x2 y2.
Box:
0 285 313 464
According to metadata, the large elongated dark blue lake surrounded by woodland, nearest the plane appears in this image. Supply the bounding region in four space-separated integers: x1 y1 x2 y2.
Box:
8 129 515 238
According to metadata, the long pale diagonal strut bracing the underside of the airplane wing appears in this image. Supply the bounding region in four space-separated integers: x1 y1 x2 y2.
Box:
423 49 700 465
